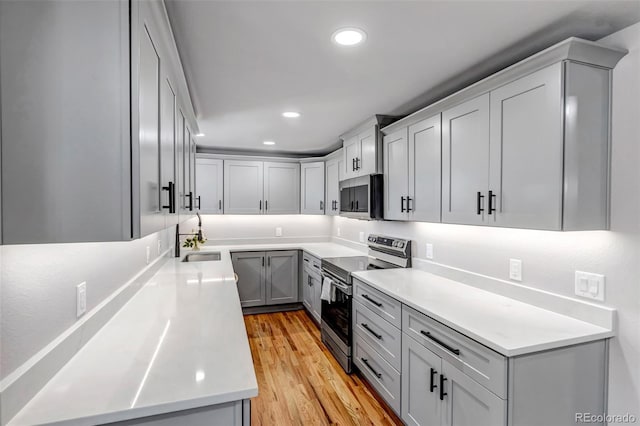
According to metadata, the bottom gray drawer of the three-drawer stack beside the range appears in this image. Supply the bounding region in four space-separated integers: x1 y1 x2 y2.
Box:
353 334 400 415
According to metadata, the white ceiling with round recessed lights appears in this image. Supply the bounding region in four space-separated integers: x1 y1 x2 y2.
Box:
166 0 640 153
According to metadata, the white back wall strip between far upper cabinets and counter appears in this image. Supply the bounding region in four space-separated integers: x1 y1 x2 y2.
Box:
199 215 332 244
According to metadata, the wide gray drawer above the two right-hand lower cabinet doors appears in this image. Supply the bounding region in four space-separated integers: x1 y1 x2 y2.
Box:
402 305 507 398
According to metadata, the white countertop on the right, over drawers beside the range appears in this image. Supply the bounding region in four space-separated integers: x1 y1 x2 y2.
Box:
354 268 614 356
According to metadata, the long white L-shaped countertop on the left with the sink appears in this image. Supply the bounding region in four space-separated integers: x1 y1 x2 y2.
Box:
9 243 363 426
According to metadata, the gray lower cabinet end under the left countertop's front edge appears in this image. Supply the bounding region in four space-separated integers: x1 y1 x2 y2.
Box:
109 399 251 426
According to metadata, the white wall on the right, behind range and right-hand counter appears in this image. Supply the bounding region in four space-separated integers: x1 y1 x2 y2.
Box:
332 24 640 418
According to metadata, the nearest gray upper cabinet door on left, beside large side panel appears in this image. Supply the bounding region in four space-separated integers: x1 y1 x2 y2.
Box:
138 24 165 236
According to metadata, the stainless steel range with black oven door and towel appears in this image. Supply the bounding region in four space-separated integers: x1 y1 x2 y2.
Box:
320 235 411 373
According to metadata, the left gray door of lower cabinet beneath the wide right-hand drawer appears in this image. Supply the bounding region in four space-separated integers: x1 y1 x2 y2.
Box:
401 334 442 426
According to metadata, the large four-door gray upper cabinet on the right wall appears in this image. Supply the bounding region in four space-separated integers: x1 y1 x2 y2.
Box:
380 38 626 231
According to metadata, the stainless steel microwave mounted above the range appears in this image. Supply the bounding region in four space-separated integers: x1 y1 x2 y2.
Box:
340 174 384 220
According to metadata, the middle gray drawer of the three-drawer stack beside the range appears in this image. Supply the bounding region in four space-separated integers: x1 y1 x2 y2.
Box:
353 301 402 371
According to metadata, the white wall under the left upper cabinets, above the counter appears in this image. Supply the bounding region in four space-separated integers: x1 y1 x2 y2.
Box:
0 227 175 379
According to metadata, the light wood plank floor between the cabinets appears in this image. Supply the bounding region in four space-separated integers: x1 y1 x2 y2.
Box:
244 310 402 426
